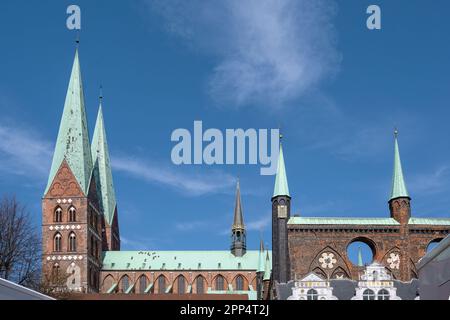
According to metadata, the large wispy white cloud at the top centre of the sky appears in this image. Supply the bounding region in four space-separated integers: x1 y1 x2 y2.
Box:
148 0 340 107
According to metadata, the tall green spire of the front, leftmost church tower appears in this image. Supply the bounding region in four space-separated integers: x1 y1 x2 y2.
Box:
45 49 92 195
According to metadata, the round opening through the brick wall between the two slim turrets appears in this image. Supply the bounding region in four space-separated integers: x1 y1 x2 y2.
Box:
346 237 377 267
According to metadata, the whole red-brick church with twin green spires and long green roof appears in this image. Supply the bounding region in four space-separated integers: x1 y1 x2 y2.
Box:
42 48 272 299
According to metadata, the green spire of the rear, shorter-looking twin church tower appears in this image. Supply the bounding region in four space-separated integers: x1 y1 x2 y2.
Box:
91 103 116 225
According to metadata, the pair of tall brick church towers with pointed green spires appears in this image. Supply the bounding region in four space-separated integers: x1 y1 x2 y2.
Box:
42 49 120 292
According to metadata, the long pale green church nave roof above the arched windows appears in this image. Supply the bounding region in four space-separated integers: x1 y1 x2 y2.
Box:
103 250 272 271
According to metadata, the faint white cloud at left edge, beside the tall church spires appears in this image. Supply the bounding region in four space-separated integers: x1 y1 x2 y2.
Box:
0 123 53 178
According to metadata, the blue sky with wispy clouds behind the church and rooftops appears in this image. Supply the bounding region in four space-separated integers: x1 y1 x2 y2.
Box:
0 0 450 262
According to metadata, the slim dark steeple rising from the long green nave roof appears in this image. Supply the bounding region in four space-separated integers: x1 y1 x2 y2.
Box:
231 180 247 257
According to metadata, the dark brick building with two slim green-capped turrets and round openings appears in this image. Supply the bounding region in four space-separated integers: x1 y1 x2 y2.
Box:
272 120 450 290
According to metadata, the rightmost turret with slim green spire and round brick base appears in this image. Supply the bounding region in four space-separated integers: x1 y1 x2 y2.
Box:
389 129 411 224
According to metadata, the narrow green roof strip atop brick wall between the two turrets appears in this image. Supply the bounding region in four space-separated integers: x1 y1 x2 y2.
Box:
288 217 399 226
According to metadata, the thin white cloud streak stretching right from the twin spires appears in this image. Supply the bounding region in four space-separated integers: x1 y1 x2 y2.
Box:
112 157 236 196
